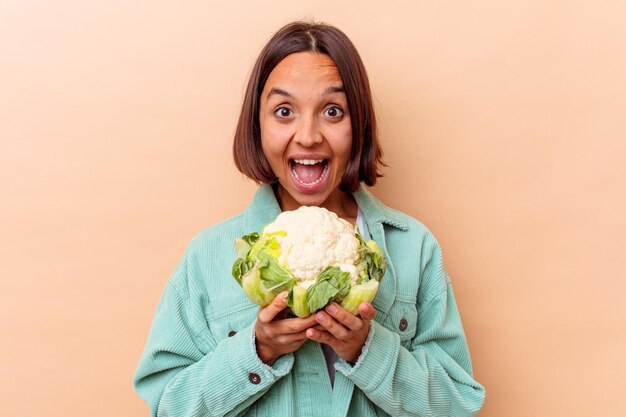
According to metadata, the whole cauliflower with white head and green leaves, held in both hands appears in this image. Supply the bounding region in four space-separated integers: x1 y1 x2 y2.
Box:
232 206 386 317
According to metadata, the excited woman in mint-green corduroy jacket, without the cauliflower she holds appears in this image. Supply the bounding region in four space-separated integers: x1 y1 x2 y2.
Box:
135 22 484 417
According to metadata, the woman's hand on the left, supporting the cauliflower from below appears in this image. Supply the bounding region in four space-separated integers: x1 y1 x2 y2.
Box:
254 292 317 365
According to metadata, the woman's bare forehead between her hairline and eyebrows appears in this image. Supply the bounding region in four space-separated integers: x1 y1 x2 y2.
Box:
263 52 343 91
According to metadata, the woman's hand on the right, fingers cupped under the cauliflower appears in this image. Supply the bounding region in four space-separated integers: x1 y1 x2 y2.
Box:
306 302 376 363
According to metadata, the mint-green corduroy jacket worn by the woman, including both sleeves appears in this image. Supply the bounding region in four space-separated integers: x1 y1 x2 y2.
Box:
134 185 485 417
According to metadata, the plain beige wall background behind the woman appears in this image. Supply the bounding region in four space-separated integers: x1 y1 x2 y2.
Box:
0 0 626 417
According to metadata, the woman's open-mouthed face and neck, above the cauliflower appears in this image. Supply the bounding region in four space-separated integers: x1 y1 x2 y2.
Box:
259 52 352 216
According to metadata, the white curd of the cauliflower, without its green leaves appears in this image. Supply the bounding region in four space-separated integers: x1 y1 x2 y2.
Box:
263 206 359 287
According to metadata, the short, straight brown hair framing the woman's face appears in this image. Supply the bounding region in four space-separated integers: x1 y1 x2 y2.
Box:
233 22 384 192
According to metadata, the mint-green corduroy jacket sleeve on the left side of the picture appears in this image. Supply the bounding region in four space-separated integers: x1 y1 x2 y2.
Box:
134 250 294 417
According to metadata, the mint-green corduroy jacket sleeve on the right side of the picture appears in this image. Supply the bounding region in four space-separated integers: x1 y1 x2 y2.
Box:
336 239 485 417
